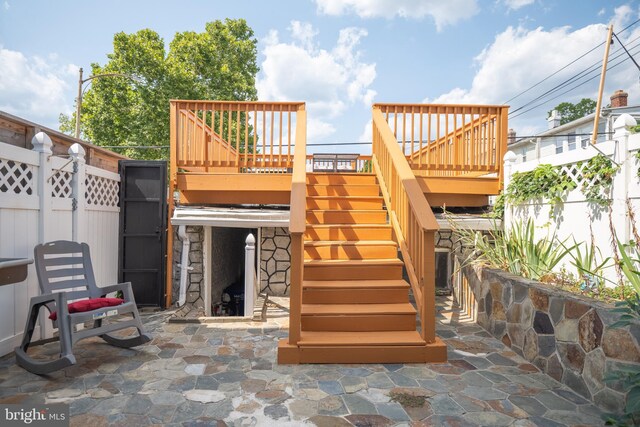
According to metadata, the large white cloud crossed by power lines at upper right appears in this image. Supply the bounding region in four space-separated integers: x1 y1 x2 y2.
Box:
424 14 640 135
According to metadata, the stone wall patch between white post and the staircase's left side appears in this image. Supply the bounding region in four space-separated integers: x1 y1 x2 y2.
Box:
260 227 291 296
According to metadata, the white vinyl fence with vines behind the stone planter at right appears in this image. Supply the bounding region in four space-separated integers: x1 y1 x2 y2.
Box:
504 114 640 281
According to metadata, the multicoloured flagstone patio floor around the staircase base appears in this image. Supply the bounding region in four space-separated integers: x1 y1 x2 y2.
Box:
0 299 603 427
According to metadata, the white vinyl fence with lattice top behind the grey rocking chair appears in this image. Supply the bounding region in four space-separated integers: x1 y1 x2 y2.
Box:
0 133 120 355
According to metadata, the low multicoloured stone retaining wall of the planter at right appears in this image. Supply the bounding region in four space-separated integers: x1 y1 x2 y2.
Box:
454 266 640 413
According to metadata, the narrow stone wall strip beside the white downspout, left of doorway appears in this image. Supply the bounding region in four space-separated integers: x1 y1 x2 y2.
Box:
172 225 204 317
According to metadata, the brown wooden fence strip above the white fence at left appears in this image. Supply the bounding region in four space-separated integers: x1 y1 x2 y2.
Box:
0 111 128 172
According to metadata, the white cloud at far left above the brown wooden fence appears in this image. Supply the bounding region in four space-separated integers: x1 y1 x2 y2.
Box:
0 46 78 129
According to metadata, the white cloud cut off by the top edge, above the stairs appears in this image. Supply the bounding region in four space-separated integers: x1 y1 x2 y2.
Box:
316 0 478 31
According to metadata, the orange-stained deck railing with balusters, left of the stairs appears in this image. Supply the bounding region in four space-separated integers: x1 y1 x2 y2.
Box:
171 101 304 173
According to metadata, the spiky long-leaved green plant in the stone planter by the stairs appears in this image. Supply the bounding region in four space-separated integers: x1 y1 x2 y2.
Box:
452 219 575 279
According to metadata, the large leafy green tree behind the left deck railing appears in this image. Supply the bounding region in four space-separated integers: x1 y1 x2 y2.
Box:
60 19 259 159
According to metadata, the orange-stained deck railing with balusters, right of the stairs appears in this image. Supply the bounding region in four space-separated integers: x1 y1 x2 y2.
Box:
374 104 509 178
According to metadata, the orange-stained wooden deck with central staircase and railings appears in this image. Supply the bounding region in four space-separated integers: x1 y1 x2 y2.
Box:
167 101 508 363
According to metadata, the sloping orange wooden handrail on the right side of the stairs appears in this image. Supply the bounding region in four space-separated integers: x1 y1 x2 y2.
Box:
372 105 439 343
